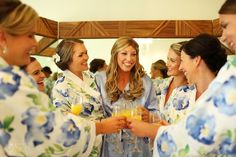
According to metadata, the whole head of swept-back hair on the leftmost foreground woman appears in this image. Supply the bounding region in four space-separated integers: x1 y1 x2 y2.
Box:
0 0 38 35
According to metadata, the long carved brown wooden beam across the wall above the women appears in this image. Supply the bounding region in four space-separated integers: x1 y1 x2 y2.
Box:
35 17 222 55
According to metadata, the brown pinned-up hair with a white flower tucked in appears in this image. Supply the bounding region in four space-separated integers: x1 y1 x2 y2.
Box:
54 39 84 70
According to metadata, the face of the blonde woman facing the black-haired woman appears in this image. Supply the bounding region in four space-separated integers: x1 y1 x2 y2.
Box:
166 49 182 76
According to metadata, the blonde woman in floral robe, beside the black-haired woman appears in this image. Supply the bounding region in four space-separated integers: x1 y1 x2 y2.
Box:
153 42 196 124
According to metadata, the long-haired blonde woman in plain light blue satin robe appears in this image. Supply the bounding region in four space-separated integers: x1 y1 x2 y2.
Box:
95 37 157 157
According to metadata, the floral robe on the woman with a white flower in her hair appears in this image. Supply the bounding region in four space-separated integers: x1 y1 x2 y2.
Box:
52 70 103 157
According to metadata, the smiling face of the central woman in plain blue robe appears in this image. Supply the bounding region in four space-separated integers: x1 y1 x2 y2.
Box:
117 46 137 72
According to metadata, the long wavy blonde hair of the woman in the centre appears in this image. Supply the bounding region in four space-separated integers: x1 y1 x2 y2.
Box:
105 37 145 102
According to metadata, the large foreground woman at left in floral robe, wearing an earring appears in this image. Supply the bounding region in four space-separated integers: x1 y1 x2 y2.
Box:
0 0 123 156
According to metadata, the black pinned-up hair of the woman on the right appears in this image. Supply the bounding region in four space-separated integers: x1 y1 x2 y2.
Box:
183 34 227 73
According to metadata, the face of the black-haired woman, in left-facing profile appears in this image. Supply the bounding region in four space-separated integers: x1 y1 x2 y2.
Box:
179 51 196 85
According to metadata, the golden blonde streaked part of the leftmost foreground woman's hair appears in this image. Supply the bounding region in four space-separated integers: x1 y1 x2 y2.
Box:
0 3 38 35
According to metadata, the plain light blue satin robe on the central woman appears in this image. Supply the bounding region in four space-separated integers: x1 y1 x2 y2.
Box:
95 72 157 157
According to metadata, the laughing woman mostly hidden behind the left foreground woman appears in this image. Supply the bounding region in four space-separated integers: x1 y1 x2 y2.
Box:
22 57 46 92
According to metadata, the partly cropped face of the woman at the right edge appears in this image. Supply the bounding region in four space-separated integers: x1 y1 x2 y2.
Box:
220 14 236 52
